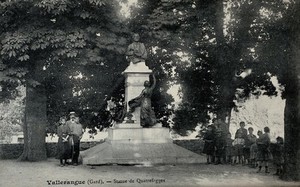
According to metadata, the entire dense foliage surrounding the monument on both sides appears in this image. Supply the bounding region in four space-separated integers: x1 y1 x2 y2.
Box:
0 0 289 135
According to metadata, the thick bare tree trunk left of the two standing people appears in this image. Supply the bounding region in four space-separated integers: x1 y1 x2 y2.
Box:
19 83 47 161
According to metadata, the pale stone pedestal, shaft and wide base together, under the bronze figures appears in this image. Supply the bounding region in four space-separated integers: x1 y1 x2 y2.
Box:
81 62 205 165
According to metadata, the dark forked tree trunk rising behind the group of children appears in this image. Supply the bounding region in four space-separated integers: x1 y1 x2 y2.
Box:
215 0 261 132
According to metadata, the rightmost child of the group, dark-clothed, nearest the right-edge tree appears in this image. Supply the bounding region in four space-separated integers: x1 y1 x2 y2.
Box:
273 136 284 175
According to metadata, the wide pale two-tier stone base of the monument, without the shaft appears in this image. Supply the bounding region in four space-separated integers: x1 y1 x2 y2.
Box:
81 128 206 165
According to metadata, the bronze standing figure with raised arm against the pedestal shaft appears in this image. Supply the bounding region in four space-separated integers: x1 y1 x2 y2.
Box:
128 74 157 127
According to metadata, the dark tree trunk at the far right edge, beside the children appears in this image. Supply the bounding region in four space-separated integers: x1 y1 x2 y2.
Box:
282 37 300 181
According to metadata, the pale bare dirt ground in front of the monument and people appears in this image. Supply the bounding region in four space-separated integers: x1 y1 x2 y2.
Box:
0 159 300 187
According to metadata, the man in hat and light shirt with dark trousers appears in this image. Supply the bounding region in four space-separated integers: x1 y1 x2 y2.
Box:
67 112 83 166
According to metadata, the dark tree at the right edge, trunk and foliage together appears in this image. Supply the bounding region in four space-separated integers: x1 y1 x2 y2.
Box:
258 1 300 181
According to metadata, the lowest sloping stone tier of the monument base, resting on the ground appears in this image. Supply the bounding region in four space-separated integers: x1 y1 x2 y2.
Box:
81 141 206 165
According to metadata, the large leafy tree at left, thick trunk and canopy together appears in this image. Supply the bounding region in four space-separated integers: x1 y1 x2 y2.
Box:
0 0 127 161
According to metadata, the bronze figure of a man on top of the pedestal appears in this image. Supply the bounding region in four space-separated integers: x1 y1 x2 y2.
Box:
126 33 147 64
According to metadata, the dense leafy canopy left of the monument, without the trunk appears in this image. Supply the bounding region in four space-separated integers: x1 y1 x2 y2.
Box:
0 0 130 130
